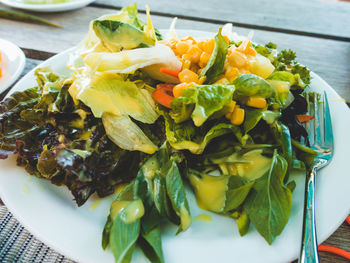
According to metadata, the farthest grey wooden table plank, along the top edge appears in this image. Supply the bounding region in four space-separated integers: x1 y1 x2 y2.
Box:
93 0 350 41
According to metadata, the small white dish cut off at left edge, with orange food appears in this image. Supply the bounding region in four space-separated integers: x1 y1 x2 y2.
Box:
0 39 26 92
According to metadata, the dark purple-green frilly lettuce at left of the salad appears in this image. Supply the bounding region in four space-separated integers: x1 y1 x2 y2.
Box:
0 69 144 205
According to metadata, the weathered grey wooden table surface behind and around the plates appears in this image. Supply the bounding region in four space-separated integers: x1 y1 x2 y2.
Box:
0 0 350 262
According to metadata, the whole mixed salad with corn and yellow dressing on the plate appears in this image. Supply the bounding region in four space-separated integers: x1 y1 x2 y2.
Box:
0 4 315 262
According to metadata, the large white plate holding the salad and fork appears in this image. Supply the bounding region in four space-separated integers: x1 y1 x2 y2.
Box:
0 31 350 263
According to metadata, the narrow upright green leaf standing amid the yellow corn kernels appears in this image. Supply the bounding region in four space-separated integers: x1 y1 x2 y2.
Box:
199 28 228 84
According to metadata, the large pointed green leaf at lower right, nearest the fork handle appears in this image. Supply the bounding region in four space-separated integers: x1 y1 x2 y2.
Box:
244 151 292 244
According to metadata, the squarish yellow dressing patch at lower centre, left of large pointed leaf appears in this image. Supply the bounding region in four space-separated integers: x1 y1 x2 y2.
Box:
190 175 229 212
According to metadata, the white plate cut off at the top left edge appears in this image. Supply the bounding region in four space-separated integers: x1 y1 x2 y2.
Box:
0 0 95 12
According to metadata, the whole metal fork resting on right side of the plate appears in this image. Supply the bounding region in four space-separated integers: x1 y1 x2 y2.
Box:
299 92 333 263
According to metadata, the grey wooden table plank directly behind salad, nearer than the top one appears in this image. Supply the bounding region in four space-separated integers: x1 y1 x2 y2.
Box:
0 5 350 101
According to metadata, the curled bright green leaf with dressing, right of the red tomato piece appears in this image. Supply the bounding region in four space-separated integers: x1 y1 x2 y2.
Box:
170 84 235 126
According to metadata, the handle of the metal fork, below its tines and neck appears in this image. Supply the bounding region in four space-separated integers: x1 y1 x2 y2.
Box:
298 167 319 263
